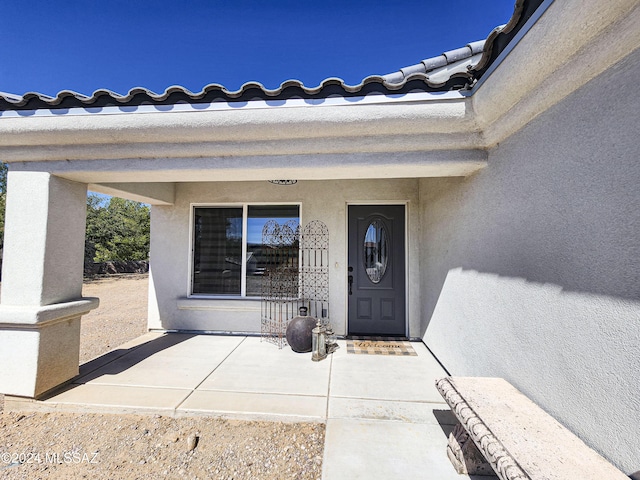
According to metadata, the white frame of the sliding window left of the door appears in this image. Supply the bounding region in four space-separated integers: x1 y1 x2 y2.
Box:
187 202 302 300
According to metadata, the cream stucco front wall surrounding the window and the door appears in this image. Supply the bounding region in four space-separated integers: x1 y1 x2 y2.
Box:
149 179 420 336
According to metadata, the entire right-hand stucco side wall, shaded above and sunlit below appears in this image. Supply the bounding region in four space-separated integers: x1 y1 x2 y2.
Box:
420 47 640 475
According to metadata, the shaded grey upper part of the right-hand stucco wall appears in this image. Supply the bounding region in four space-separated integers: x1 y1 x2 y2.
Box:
420 49 640 328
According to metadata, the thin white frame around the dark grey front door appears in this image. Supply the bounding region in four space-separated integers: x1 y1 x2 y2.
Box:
342 200 411 338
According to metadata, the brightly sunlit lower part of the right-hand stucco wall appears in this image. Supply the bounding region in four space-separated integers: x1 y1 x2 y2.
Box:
424 268 640 472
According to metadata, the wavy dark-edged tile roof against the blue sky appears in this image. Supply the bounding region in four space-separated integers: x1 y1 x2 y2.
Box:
0 0 543 111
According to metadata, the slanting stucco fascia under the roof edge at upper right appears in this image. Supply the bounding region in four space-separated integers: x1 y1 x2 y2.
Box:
470 0 640 148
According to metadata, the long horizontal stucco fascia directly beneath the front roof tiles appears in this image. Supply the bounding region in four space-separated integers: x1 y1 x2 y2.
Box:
0 92 481 163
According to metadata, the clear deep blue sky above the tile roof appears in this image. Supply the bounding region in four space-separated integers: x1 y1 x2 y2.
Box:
0 0 515 95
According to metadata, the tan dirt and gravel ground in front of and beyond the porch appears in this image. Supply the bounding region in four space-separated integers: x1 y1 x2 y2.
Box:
0 274 324 479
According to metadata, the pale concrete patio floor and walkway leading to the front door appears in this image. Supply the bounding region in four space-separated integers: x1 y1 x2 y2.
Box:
5 332 496 480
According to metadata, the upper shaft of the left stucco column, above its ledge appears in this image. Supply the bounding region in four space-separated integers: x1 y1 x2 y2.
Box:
2 171 87 306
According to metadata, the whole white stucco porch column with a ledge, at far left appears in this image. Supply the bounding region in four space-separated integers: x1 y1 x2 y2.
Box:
0 171 98 397
